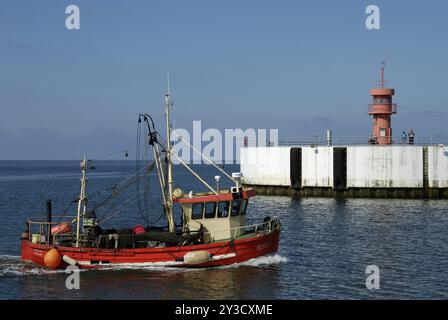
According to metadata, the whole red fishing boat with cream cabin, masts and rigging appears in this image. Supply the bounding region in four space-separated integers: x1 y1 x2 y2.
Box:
21 93 281 269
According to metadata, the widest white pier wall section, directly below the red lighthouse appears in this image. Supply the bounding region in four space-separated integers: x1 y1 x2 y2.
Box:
347 146 423 188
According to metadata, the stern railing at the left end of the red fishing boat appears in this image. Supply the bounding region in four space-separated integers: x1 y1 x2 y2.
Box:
27 216 76 244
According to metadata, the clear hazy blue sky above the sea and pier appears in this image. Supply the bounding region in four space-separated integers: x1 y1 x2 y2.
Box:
0 0 448 159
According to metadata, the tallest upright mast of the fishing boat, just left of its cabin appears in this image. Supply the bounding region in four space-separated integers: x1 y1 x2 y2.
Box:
165 83 176 232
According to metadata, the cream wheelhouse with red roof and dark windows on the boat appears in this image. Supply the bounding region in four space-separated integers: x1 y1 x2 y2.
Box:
174 187 255 243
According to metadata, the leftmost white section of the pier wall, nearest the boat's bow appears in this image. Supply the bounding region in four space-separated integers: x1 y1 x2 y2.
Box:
240 147 291 186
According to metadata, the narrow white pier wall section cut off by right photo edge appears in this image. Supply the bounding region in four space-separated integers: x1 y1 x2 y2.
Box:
428 146 448 188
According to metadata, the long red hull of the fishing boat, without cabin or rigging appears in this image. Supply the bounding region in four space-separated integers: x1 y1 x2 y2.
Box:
22 230 280 268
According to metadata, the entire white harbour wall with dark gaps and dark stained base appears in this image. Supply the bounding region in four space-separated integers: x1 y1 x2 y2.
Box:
240 145 448 199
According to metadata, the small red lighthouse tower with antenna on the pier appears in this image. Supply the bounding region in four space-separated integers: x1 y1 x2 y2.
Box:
368 60 397 144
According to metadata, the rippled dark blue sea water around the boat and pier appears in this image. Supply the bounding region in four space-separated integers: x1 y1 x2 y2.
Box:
0 161 448 299
